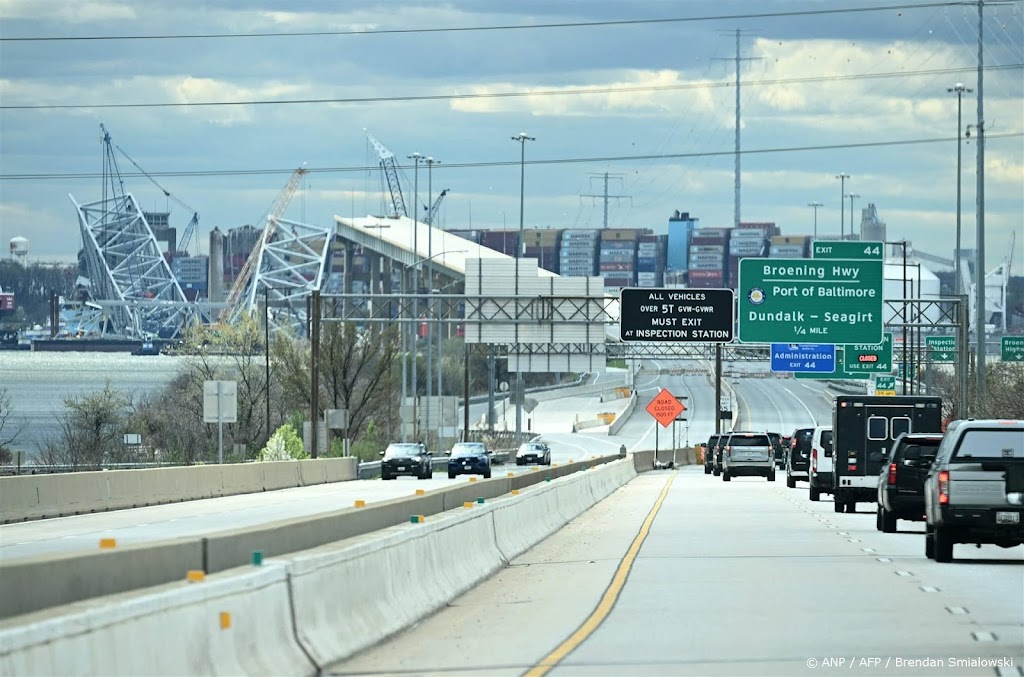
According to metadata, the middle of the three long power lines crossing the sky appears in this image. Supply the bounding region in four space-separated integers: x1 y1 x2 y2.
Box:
0 64 1024 111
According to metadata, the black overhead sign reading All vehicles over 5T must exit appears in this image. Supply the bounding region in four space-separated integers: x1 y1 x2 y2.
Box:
618 287 735 343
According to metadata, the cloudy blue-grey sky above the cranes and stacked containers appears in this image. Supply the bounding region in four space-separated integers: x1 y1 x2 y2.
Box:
0 0 1024 274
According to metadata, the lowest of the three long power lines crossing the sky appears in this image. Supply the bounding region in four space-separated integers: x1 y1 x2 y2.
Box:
0 131 1024 181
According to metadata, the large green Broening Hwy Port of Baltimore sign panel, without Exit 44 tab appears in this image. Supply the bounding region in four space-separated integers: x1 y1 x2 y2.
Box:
737 257 882 343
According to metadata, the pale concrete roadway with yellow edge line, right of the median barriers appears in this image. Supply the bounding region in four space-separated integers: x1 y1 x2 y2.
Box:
327 467 1024 676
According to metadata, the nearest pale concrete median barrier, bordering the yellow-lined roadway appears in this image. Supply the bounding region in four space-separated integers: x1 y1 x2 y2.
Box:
0 459 649 675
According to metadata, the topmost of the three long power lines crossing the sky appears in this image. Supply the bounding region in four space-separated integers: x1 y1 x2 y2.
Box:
0 0 963 42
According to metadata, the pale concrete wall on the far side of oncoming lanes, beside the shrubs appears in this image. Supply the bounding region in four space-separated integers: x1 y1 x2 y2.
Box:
0 458 357 523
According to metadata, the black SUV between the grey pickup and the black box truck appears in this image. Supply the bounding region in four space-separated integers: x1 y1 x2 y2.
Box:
874 432 942 534
